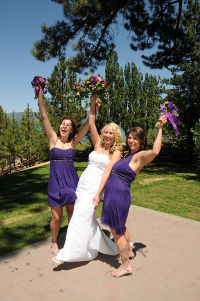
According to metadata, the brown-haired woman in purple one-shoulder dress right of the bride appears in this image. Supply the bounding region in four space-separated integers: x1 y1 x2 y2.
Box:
93 115 167 277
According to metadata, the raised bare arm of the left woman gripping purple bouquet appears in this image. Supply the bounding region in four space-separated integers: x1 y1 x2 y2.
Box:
38 86 57 144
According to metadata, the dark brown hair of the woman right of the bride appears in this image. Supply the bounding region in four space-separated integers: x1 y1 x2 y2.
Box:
124 127 147 156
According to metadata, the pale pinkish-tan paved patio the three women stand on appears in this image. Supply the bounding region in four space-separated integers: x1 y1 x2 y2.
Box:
0 206 200 301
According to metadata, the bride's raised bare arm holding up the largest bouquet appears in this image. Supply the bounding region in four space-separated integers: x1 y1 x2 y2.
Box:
89 94 101 149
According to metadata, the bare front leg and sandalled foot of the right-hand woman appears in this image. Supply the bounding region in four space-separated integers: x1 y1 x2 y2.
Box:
110 228 132 276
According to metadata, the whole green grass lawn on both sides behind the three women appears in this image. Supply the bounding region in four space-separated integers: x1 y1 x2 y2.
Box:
0 159 200 255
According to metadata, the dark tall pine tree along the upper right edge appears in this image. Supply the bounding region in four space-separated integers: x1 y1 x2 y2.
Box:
166 0 200 159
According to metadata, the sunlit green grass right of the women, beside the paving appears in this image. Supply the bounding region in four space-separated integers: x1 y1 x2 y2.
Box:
131 170 200 221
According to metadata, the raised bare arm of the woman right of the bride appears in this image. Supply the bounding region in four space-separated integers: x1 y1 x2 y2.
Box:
130 115 167 173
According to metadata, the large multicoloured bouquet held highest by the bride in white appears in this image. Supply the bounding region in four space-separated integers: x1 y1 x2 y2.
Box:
73 75 108 98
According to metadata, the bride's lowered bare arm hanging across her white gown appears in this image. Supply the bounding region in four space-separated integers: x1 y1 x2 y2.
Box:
93 151 121 210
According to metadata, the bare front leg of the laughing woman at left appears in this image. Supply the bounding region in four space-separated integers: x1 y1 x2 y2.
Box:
50 207 63 251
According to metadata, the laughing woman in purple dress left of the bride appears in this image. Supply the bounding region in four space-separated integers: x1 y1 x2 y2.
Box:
38 87 98 255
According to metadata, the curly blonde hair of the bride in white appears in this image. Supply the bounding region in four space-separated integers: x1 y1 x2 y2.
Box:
100 122 122 154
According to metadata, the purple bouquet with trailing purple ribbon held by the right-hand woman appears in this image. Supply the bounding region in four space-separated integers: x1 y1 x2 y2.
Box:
155 101 182 136
